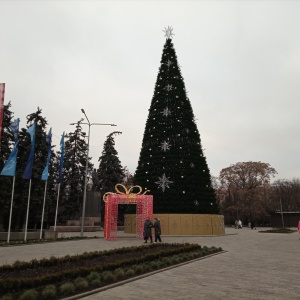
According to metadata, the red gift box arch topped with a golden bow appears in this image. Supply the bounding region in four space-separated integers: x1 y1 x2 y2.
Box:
103 183 153 240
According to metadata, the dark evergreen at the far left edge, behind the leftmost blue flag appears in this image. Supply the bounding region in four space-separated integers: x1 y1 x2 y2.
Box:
0 102 14 231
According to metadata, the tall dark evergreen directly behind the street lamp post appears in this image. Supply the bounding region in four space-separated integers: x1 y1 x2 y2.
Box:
58 121 93 222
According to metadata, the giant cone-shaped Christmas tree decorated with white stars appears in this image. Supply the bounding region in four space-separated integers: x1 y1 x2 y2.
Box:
134 27 219 214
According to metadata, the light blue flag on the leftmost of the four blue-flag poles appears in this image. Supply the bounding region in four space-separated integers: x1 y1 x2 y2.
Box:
0 119 20 176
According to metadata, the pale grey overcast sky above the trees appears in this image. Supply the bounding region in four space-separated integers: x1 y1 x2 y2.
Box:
0 0 300 179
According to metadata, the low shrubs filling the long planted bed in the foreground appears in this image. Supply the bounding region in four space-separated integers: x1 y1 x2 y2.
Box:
0 244 222 300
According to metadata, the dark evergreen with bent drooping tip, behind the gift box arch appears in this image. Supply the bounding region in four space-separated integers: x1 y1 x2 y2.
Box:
97 131 125 222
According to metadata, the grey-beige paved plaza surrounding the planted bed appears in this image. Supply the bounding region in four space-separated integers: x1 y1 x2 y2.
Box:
0 228 300 300
